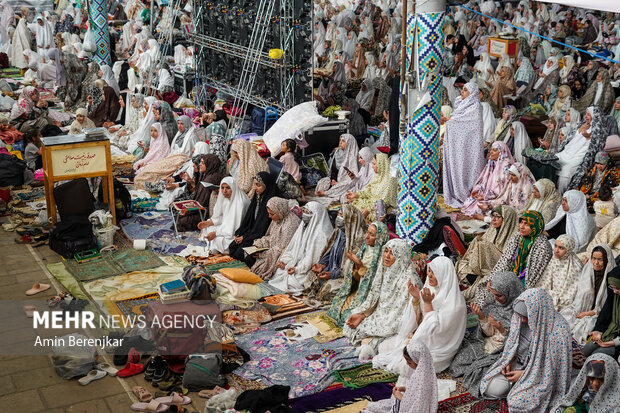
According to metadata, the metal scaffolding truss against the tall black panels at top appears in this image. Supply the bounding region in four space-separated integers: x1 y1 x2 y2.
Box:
191 0 312 130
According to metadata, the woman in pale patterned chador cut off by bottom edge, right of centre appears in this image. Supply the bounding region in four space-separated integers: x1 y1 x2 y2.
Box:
362 340 438 413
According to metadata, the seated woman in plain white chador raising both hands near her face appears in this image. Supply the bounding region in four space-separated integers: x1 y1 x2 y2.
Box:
373 256 467 372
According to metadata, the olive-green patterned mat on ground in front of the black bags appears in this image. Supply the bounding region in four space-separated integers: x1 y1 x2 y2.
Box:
65 249 166 281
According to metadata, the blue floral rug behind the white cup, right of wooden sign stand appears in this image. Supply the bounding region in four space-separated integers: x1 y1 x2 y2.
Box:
121 211 204 255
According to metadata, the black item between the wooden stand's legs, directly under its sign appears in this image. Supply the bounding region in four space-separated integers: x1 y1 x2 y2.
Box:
50 178 95 219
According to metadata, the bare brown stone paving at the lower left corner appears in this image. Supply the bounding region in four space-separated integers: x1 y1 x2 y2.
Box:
0 225 205 413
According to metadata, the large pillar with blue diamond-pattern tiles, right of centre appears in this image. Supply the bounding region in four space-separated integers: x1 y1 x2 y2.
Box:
396 0 446 244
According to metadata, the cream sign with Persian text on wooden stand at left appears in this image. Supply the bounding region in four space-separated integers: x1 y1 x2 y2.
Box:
51 146 108 177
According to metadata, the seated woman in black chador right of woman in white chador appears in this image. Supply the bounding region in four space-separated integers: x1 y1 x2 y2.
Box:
228 172 277 261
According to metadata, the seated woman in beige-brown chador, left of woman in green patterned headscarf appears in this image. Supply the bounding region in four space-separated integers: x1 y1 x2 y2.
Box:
456 206 519 301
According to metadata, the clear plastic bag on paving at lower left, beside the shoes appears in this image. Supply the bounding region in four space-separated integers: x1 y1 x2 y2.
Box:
52 333 97 380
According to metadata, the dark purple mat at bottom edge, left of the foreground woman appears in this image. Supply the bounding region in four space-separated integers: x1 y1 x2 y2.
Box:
289 383 392 412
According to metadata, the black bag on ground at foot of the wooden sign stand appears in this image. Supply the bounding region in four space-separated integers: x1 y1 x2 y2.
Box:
49 216 97 258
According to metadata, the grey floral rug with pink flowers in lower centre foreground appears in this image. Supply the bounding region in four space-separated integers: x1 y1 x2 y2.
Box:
230 317 358 398
